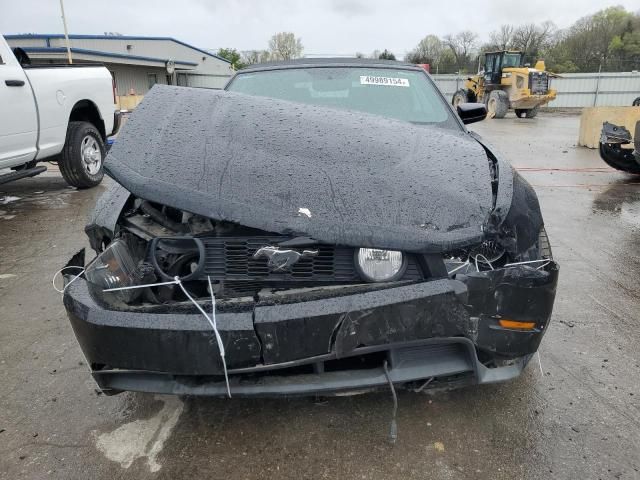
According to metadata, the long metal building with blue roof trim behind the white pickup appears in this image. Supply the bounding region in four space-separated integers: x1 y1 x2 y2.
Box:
4 34 233 110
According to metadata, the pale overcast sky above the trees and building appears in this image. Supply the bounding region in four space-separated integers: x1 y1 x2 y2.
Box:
0 0 638 57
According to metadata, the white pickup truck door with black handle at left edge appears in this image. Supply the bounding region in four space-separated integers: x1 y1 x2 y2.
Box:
0 36 38 169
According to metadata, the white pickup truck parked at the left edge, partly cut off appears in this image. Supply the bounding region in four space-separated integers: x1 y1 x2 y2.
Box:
0 35 120 188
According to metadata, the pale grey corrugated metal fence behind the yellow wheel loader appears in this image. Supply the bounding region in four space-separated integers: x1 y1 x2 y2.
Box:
433 72 640 107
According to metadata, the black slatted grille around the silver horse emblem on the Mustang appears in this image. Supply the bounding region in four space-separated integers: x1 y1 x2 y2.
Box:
201 236 422 287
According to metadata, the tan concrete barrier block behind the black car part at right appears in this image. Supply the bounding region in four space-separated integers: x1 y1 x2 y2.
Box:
578 107 640 148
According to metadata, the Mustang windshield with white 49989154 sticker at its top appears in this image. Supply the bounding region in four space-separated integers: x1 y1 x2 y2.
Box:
227 67 461 130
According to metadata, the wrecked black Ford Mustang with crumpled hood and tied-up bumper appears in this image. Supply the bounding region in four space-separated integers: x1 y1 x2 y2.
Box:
64 60 558 396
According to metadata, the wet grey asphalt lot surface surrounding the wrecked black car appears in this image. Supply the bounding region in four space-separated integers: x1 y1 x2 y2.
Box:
0 113 640 479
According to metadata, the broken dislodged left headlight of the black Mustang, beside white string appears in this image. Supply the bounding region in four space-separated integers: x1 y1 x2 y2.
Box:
84 239 141 302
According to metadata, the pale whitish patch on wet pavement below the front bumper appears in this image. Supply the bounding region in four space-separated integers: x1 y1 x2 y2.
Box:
96 396 184 472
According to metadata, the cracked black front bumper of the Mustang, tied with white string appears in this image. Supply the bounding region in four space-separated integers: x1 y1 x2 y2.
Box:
64 263 558 396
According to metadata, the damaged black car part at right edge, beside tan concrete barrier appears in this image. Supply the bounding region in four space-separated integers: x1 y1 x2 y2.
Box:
600 122 640 174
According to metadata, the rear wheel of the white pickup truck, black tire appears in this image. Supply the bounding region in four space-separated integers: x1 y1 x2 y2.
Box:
58 122 105 188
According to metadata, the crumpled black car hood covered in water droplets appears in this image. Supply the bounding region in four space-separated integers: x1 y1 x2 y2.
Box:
105 85 493 252
